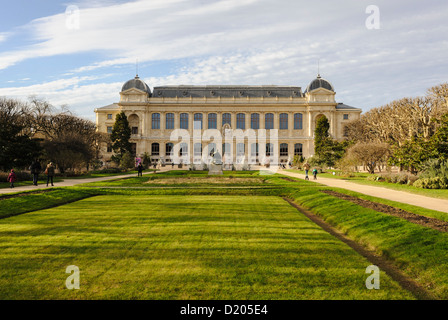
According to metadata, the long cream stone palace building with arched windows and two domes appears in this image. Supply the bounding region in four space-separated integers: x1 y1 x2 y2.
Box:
95 76 361 163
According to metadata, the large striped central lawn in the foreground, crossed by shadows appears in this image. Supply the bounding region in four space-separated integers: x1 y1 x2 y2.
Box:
0 195 413 300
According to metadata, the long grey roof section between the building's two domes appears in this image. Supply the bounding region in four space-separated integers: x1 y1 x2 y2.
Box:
153 85 303 98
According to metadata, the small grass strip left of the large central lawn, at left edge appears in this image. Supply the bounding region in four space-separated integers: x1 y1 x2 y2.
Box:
0 188 93 219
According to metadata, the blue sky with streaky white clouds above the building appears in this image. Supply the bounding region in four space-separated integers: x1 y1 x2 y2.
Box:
0 0 448 120
